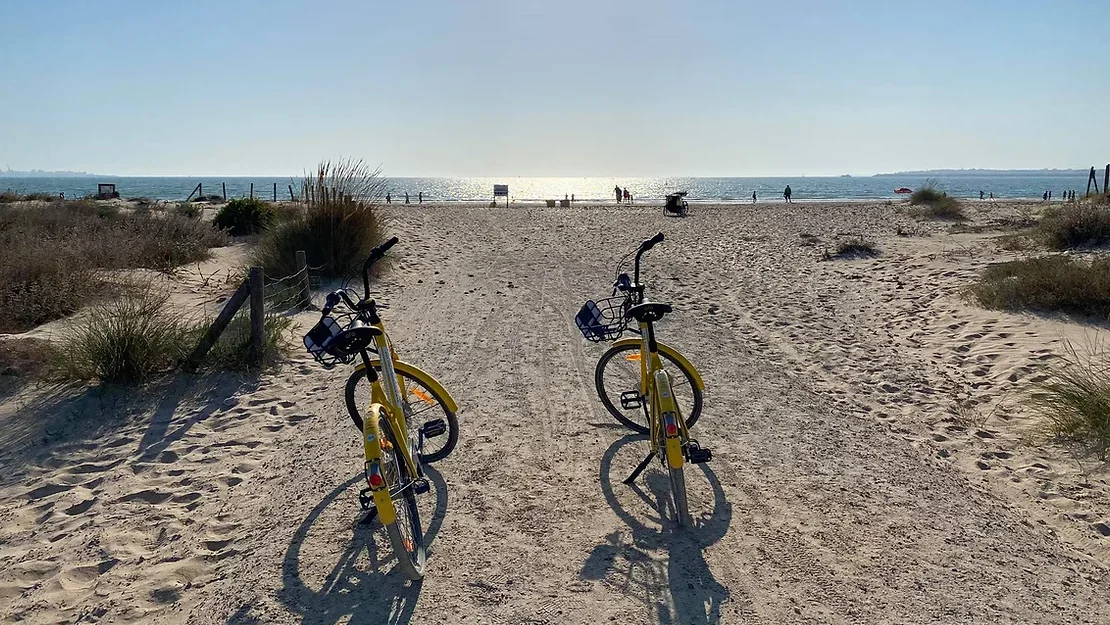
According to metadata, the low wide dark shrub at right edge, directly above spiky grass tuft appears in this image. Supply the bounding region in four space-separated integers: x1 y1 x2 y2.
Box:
971 255 1110 319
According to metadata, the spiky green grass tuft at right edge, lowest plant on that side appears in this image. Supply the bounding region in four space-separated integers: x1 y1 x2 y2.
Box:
1032 345 1110 461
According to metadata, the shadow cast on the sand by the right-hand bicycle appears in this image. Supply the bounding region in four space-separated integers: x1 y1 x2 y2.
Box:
579 434 733 625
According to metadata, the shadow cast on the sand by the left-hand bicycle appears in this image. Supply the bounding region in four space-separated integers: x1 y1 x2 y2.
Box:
278 465 447 625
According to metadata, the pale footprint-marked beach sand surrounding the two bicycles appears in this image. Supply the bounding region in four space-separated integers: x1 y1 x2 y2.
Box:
0 202 1110 624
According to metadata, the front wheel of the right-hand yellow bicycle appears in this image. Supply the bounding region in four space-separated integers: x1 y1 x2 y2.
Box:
594 344 702 434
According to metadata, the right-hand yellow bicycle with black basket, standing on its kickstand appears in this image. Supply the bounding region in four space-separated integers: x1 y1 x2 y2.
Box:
575 232 713 525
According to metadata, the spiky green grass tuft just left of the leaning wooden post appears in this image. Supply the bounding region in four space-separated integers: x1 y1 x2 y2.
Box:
58 289 193 382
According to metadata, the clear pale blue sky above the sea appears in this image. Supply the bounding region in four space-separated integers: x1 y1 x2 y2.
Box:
0 0 1110 177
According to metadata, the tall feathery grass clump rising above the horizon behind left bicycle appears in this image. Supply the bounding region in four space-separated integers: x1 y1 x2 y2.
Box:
253 160 385 278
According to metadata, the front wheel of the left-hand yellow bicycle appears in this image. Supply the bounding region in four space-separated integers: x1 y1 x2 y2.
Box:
344 367 458 463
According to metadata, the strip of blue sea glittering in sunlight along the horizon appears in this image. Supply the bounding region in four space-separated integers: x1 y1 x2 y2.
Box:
0 170 1102 203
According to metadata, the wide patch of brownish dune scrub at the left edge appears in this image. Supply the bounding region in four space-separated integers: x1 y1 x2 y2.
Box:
0 200 226 332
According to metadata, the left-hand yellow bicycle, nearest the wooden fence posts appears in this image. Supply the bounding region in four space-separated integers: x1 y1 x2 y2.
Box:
304 236 458 581
